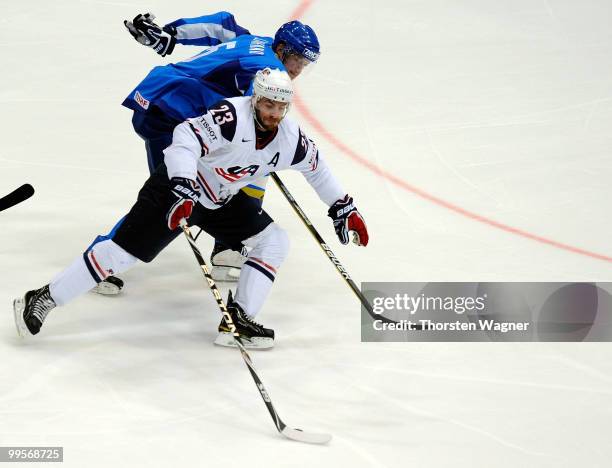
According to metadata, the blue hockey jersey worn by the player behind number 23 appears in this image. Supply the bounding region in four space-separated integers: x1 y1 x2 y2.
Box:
123 12 285 121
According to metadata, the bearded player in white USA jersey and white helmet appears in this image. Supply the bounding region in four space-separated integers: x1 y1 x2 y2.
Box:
13 69 368 348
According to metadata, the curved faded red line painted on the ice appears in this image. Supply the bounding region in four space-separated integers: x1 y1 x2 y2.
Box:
290 0 612 263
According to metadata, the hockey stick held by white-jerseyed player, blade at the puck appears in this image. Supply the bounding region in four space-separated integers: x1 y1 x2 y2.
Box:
180 219 331 444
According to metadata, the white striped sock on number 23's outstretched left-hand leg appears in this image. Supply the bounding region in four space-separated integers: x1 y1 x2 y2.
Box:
49 239 138 306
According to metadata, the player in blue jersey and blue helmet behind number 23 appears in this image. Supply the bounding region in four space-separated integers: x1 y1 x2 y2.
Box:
96 12 320 294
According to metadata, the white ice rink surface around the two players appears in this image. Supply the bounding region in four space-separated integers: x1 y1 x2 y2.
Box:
0 0 612 468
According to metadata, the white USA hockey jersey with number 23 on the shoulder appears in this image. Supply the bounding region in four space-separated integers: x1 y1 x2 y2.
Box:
164 97 346 209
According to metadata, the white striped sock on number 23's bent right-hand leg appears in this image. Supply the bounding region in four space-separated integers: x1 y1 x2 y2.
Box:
235 223 289 317
